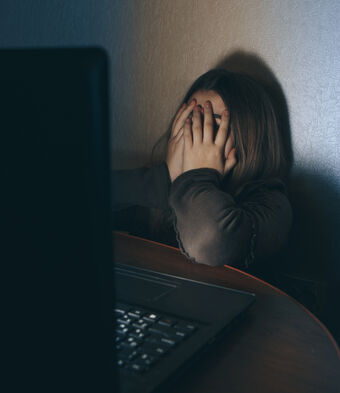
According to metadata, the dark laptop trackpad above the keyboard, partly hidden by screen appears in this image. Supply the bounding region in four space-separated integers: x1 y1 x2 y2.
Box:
116 271 176 302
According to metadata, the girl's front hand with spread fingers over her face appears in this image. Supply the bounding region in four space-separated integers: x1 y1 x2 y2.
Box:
183 101 237 176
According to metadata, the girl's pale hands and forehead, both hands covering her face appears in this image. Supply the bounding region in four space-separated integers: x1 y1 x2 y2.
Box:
167 91 236 181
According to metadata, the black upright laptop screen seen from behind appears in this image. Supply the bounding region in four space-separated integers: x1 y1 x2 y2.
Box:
0 49 115 392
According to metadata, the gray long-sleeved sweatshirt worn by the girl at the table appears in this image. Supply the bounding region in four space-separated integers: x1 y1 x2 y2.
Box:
112 163 292 270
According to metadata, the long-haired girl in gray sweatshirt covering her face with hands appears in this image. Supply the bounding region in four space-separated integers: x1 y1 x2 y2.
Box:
113 69 292 278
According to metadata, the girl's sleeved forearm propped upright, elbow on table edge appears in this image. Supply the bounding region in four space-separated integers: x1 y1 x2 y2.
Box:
170 169 251 266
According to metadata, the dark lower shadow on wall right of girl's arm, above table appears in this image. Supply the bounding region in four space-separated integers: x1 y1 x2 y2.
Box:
284 168 340 343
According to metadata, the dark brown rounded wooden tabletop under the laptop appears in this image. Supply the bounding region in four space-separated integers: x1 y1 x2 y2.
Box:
113 232 340 393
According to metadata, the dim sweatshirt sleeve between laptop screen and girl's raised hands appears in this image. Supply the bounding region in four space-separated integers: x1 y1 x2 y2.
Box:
111 162 171 211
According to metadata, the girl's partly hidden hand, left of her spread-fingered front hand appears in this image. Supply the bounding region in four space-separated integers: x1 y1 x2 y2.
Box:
166 100 196 182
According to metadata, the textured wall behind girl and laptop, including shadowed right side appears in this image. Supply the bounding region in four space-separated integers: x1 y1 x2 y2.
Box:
0 0 340 334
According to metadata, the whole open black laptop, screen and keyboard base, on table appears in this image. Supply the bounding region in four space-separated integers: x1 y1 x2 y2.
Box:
0 48 255 393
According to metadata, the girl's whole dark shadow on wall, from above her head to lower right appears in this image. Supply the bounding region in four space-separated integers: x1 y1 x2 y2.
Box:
215 51 340 342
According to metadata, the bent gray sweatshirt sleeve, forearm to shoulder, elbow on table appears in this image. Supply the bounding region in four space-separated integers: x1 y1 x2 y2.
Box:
169 168 292 267
